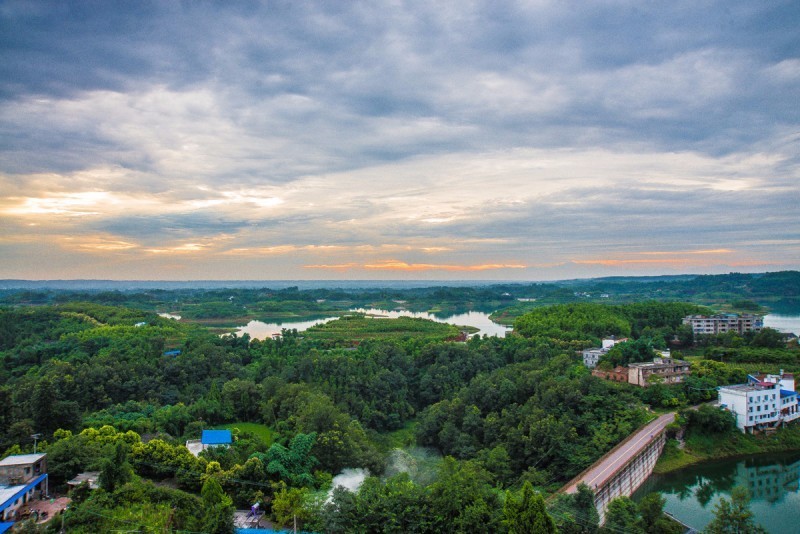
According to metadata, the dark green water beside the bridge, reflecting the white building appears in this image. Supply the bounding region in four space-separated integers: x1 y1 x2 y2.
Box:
633 453 800 533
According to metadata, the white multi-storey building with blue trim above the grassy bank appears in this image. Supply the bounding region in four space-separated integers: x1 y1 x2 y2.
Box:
719 375 800 433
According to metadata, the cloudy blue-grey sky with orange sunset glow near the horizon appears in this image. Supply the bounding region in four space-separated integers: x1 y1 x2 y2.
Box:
0 0 800 281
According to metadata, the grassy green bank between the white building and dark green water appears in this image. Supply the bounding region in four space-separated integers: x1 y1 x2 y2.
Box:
653 424 800 474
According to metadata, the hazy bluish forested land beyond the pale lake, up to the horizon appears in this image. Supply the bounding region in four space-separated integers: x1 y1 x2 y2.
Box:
0 271 800 325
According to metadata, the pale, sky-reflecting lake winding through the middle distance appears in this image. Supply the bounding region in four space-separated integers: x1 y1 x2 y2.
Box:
231 308 511 339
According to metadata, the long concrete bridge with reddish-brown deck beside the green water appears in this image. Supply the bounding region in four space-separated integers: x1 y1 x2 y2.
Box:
560 413 675 524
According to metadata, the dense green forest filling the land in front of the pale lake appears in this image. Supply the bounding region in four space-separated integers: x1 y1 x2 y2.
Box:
0 273 798 532
